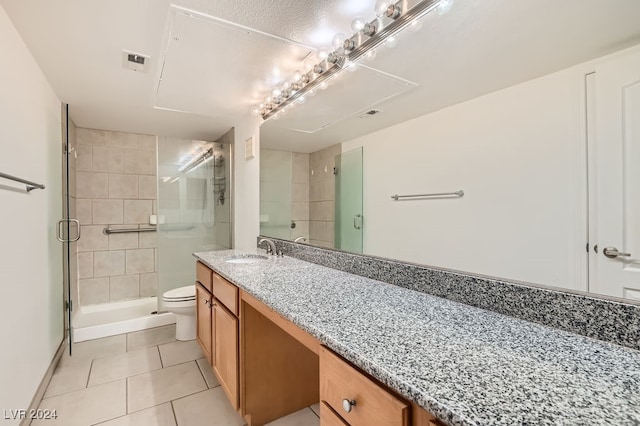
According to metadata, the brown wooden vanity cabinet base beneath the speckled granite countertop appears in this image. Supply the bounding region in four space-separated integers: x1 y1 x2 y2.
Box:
196 262 442 426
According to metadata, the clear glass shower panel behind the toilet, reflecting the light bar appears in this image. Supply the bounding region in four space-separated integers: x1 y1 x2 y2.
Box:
156 137 231 311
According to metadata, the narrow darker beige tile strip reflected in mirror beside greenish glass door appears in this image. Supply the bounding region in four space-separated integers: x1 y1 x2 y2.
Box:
309 144 342 248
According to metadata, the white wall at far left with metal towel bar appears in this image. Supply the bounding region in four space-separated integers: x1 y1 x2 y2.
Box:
0 7 63 424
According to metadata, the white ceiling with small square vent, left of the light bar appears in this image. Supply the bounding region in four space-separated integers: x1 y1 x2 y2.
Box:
0 0 372 139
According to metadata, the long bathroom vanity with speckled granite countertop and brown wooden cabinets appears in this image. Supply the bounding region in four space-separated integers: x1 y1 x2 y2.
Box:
195 250 640 426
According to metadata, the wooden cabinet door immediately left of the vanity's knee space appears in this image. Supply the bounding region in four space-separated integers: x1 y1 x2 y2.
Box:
213 299 239 410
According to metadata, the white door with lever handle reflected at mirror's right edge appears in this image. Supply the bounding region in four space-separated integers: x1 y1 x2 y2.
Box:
587 49 640 300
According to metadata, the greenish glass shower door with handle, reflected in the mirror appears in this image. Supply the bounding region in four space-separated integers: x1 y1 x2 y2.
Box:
335 148 364 253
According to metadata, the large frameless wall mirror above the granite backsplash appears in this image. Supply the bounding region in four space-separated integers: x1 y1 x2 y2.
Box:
260 0 640 300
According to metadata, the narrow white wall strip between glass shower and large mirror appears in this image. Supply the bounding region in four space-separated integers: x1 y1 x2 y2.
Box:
232 116 260 250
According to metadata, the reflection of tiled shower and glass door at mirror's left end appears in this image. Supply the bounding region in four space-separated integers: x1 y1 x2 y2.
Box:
260 145 363 253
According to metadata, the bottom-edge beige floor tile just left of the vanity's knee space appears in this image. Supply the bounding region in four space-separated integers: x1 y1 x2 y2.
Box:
173 386 245 426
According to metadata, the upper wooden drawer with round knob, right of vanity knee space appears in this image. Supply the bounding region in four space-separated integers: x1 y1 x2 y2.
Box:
320 347 411 426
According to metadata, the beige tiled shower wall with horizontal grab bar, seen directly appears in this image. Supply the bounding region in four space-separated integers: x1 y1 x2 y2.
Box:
76 128 158 305
